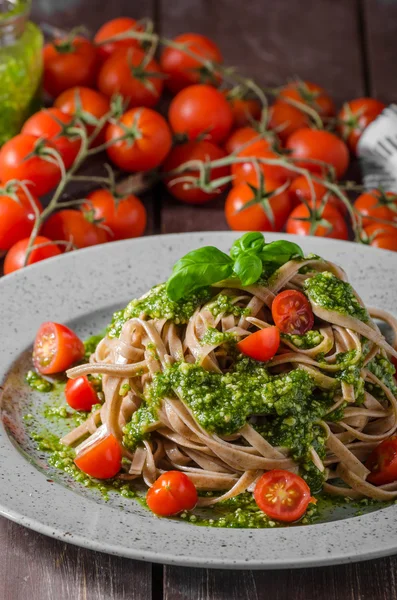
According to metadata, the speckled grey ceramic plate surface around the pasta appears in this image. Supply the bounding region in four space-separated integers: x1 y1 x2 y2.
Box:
0 232 397 569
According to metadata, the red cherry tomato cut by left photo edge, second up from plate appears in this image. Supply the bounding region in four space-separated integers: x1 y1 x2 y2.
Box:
0 185 43 252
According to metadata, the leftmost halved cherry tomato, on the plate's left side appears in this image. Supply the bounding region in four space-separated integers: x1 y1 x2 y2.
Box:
33 321 84 375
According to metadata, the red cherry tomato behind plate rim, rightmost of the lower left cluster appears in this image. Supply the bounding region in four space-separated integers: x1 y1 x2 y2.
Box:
83 189 147 240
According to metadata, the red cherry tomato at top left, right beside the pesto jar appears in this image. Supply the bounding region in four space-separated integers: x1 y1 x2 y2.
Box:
43 36 97 98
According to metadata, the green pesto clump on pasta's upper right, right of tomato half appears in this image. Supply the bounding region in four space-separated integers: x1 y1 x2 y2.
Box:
304 271 369 323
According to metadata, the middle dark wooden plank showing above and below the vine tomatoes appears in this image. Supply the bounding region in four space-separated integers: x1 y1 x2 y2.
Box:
160 0 364 233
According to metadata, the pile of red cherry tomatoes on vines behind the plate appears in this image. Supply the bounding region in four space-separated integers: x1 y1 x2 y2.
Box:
0 17 397 274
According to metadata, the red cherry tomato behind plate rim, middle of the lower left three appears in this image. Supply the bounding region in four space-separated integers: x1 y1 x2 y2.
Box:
43 209 110 248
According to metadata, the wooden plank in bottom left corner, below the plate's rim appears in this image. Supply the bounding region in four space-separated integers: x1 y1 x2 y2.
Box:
0 518 152 600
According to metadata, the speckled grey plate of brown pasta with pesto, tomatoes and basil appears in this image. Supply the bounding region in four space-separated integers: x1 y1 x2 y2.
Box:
0 232 397 569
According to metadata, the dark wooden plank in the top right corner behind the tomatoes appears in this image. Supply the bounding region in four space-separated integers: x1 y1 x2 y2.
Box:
361 0 397 102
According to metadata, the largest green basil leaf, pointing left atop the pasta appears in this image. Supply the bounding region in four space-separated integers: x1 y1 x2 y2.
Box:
167 246 233 301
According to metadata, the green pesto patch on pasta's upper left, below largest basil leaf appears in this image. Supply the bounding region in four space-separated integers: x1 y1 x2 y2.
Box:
107 283 211 338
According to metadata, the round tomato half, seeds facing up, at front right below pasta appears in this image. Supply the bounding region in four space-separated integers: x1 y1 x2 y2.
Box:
254 469 312 523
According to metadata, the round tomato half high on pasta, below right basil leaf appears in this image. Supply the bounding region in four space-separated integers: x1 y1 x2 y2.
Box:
272 290 314 335
